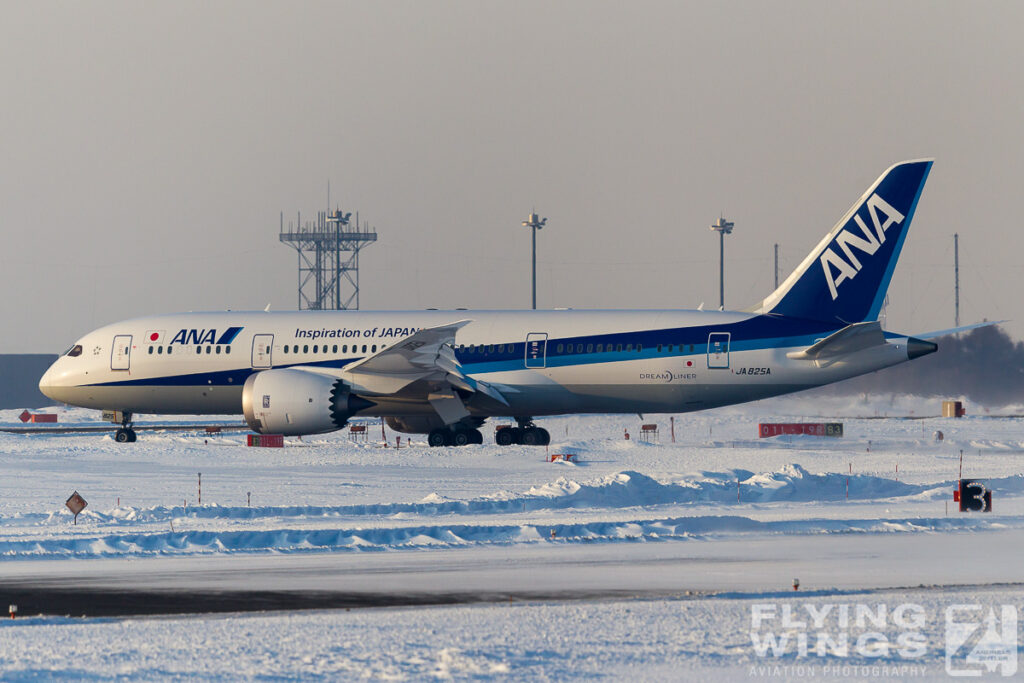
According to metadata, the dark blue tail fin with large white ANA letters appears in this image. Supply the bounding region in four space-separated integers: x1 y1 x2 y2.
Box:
753 159 932 324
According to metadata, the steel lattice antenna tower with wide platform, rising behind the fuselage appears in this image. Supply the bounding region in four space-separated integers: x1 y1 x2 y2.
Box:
281 202 377 310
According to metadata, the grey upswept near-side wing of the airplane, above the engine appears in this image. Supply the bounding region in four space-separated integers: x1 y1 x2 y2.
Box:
341 321 508 409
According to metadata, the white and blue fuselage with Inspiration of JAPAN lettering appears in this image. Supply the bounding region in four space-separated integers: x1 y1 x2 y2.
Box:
40 310 907 417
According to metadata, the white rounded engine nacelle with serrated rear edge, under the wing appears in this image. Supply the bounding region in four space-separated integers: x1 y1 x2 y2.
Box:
242 369 373 436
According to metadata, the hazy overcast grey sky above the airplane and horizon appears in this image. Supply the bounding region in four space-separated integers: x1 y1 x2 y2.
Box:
0 0 1024 352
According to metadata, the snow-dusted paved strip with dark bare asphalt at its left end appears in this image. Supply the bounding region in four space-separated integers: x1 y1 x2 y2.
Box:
0 529 1024 616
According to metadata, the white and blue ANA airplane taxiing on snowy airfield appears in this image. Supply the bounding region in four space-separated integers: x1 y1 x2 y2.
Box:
39 159 948 446
